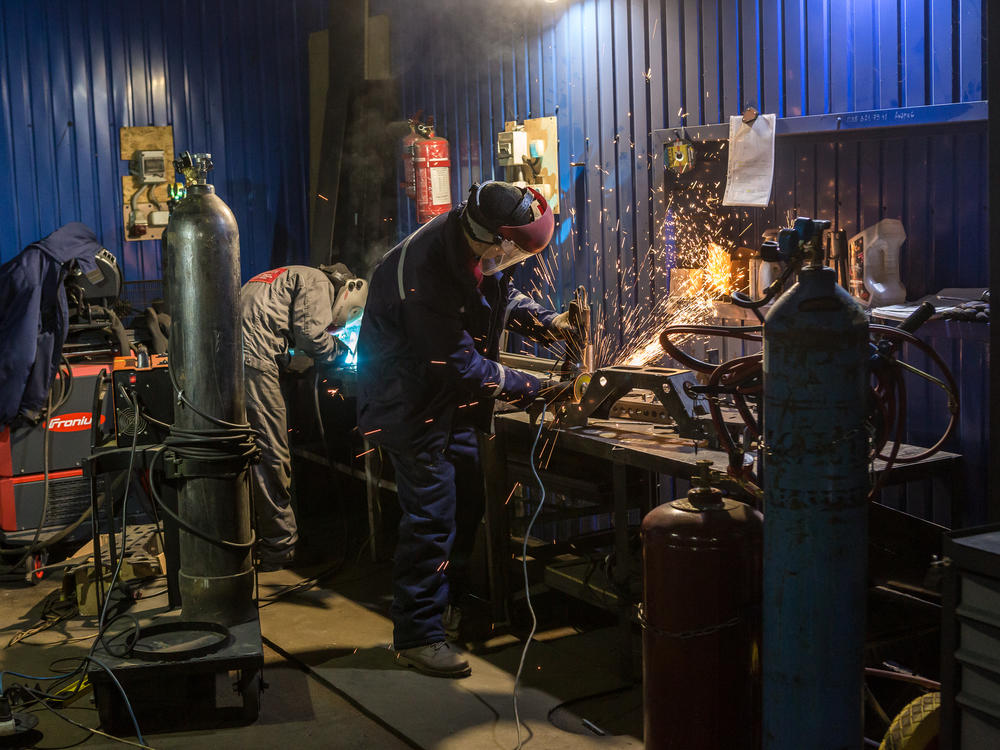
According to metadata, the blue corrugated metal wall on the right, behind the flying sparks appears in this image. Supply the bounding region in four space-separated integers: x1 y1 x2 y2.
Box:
373 0 989 521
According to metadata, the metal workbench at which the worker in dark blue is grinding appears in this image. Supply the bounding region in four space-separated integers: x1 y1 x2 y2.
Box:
482 412 959 674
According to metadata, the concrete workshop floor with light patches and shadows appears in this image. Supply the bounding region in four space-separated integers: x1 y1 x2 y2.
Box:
0 562 642 750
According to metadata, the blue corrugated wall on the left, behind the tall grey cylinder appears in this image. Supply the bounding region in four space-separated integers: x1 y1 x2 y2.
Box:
0 0 328 280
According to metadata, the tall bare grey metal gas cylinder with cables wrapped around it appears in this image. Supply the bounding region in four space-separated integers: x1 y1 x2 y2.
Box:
163 173 256 624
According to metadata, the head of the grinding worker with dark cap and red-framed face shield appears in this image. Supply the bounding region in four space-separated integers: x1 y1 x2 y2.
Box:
462 180 555 276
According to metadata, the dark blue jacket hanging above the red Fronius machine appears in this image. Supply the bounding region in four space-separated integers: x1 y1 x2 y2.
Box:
0 221 101 426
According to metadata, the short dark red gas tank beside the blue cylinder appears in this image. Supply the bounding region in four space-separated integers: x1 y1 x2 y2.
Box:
641 461 763 750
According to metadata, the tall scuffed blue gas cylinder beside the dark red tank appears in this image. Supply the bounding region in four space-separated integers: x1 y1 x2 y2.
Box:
762 265 869 750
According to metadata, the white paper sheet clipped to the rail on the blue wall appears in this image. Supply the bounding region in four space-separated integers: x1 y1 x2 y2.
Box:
722 115 775 208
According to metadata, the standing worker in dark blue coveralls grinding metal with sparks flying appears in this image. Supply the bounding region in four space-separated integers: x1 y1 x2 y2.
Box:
358 182 573 677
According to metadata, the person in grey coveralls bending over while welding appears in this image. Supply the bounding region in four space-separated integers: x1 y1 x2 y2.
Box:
240 263 368 570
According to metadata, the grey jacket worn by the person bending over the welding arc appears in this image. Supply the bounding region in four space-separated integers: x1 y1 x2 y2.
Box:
240 266 338 375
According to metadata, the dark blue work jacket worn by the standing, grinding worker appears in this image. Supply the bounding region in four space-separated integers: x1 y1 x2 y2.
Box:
357 206 556 452
